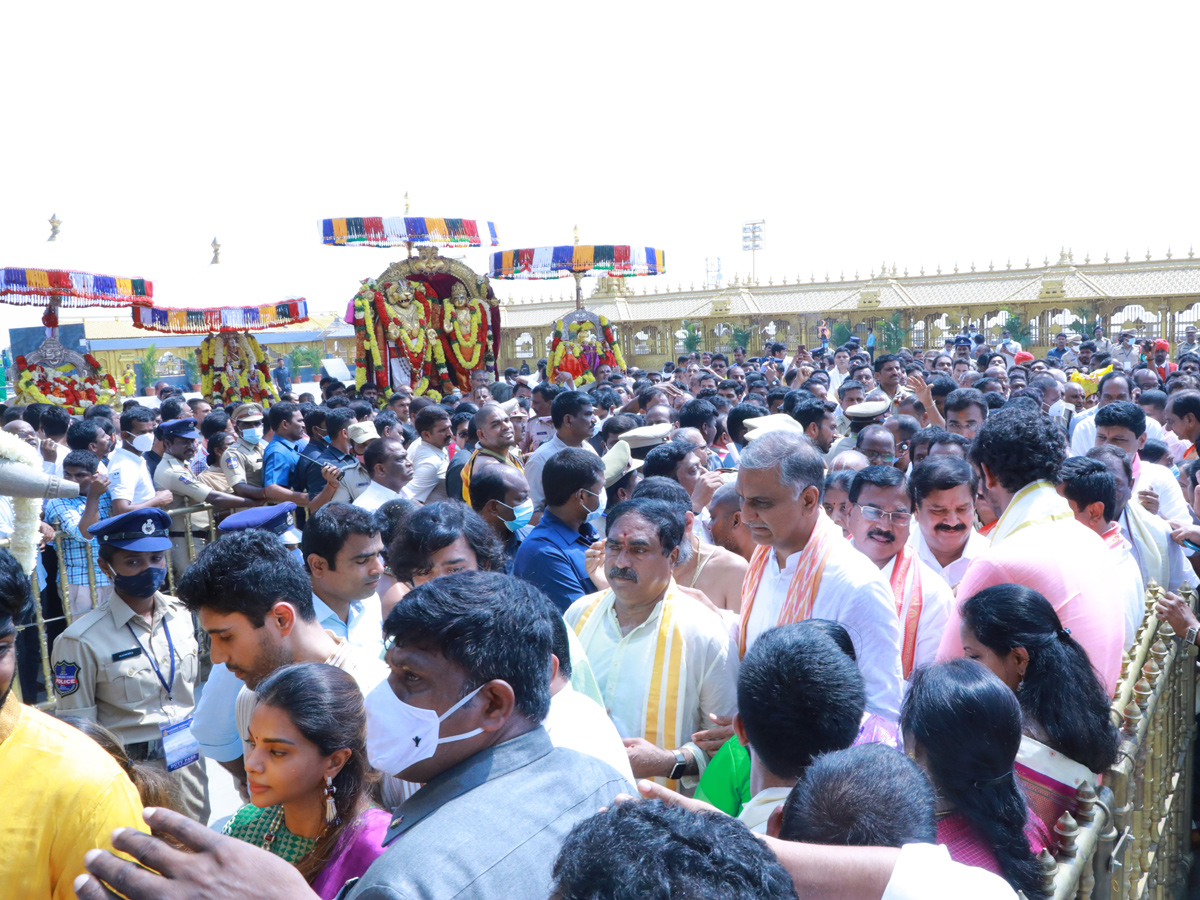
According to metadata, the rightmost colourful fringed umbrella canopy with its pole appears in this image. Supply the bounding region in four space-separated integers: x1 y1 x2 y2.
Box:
487 229 666 310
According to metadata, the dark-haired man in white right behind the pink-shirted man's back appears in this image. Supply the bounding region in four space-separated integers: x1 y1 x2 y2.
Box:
1058 456 1146 649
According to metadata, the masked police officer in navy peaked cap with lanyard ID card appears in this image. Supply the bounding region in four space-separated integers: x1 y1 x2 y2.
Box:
53 509 210 823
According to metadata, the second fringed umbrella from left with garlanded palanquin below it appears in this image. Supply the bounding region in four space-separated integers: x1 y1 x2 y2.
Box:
133 238 308 406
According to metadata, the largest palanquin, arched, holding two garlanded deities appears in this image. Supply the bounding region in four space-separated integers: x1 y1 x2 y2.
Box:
347 247 500 398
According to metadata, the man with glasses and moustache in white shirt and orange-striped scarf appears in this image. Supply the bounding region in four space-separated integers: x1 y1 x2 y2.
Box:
850 468 956 678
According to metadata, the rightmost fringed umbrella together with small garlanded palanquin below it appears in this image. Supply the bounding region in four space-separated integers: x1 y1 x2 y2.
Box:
488 228 666 382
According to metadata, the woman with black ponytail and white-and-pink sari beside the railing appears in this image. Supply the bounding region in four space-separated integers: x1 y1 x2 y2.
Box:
961 584 1120 828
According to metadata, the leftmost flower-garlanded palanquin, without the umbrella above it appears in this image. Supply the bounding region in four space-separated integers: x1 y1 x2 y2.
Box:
16 304 118 414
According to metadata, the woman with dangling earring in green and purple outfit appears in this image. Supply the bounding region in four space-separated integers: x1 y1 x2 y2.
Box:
224 662 391 900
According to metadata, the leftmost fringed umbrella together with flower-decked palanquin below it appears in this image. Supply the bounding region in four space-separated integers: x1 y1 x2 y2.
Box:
0 215 154 413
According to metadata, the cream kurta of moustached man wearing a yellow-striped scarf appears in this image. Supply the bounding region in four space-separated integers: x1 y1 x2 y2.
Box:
564 585 738 787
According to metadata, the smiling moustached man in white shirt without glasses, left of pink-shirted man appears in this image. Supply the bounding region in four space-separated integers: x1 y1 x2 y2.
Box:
908 455 988 588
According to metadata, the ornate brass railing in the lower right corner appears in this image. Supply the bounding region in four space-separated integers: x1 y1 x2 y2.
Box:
1040 583 1196 900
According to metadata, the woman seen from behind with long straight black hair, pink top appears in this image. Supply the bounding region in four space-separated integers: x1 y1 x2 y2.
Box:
900 659 1050 898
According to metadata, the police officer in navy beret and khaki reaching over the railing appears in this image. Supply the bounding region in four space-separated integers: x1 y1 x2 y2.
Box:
154 419 254 580
